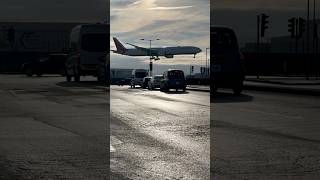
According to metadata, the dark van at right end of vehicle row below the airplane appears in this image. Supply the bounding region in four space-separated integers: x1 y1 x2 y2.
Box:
160 69 187 91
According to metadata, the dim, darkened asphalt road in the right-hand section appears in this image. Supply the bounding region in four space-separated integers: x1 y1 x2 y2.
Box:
211 91 320 180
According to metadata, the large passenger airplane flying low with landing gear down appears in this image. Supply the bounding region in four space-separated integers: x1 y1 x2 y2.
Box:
111 37 201 61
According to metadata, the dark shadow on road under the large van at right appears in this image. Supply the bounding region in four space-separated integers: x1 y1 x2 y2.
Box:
211 92 253 103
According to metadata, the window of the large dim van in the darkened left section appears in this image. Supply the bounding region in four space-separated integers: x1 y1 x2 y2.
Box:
81 33 109 52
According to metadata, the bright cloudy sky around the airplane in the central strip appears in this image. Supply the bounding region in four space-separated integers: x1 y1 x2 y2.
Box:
110 0 210 71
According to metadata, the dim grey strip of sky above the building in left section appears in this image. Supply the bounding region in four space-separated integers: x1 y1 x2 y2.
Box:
0 0 110 22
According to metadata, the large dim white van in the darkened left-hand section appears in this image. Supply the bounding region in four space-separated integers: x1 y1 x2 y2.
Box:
66 24 110 81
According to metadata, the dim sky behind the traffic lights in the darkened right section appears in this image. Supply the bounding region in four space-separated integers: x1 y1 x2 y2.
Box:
211 0 320 45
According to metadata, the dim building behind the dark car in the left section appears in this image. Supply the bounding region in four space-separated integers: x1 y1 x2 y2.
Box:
0 22 83 72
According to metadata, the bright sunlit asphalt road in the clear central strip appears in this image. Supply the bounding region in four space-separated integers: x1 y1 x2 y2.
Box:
110 86 210 180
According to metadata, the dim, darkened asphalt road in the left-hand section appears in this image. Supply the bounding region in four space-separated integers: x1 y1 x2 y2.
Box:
0 75 110 179
